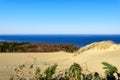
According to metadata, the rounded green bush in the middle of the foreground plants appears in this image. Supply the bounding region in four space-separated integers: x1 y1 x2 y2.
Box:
69 63 82 80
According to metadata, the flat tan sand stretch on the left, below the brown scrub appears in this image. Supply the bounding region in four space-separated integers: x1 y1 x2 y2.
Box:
0 51 74 80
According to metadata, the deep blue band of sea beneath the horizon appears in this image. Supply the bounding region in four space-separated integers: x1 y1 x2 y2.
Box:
0 34 120 47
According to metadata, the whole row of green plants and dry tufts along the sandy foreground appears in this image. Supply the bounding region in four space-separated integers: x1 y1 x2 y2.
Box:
9 62 120 80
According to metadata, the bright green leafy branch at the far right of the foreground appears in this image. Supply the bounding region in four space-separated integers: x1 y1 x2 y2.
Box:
102 62 118 75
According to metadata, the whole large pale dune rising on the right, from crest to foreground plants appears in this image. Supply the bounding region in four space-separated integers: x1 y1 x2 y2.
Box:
62 41 120 74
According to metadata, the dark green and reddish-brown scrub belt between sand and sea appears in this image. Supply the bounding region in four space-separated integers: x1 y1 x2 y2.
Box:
0 42 79 52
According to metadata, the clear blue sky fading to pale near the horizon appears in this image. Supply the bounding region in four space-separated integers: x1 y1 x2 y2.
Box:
0 0 120 34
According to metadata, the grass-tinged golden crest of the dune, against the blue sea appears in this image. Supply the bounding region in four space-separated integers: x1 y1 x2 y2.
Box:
78 41 120 53
